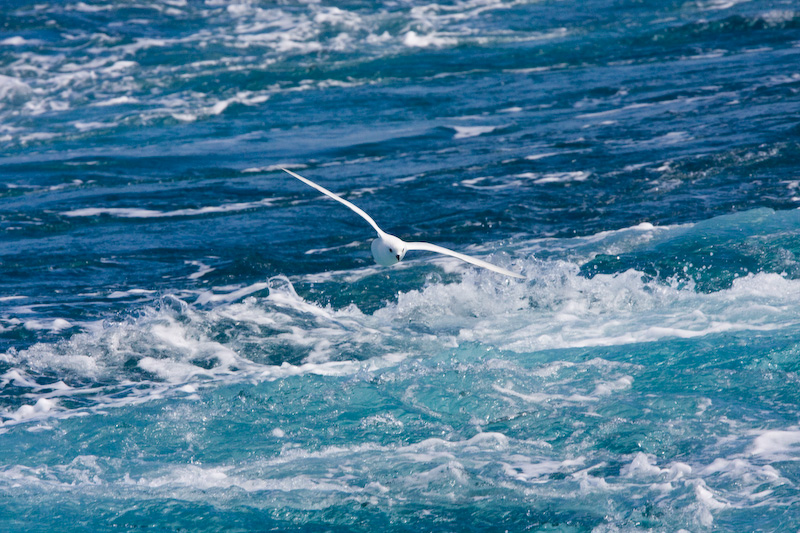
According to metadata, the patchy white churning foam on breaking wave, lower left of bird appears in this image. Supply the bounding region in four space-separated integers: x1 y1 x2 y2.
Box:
0 278 406 426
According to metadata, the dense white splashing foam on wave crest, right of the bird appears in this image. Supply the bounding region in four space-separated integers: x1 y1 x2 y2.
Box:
434 263 800 352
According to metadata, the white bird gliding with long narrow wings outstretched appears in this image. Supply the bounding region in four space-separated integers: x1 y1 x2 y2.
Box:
281 168 525 279
